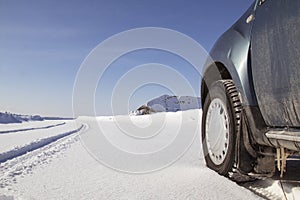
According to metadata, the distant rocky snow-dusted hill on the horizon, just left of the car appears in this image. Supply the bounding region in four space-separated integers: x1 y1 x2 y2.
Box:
131 95 201 115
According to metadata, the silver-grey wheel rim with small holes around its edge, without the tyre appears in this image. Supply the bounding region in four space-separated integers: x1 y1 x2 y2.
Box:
205 98 229 165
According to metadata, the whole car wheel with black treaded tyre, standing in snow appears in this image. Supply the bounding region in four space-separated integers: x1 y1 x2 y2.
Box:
202 80 241 176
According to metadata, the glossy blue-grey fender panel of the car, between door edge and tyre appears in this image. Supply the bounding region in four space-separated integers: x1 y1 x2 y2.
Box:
202 3 257 105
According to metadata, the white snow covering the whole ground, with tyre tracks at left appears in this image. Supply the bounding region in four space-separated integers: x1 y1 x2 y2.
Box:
0 109 300 200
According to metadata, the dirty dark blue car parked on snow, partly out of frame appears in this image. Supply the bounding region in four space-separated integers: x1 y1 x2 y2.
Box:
201 0 300 181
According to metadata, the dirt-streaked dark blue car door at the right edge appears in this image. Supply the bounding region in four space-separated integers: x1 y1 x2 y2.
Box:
251 0 300 127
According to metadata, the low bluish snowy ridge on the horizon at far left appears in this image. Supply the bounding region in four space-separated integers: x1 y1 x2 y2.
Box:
0 112 44 124
